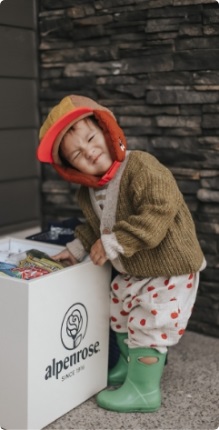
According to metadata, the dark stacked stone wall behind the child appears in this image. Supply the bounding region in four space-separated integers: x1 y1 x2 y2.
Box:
39 0 219 336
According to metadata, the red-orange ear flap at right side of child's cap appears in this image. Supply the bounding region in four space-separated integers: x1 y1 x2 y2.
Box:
94 110 127 161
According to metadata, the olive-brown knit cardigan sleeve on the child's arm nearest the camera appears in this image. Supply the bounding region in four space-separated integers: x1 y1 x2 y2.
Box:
113 153 182 257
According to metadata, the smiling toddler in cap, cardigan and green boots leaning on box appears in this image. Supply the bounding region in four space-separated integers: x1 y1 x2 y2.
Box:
38 95 205 412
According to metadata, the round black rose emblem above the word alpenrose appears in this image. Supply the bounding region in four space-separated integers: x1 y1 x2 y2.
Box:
61 303 88 349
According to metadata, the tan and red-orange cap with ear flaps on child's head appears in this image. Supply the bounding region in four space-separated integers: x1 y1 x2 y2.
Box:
37 95 126 187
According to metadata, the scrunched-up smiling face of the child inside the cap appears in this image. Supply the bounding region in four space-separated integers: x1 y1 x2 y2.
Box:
60 118 113 176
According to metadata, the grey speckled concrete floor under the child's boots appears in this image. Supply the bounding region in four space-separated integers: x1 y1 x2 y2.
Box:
44 331 219 430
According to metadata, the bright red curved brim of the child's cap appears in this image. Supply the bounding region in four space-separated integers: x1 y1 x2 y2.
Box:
37 107 93 164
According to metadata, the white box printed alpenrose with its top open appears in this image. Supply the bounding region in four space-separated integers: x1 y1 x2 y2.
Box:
0 237 111 430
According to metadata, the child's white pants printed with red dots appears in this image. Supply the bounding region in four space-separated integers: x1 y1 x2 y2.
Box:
110 272 199 353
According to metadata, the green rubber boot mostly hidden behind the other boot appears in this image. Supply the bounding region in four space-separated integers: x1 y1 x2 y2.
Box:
108 333 128 385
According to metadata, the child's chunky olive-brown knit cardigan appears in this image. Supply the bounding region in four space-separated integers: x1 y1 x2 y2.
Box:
75 151 204 277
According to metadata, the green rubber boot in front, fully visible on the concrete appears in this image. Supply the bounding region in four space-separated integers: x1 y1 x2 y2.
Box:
96 348 166 412
